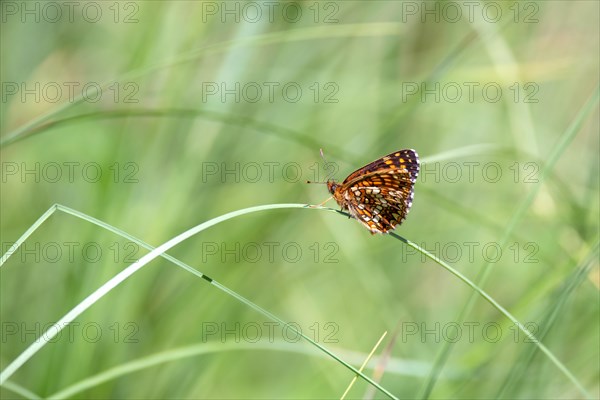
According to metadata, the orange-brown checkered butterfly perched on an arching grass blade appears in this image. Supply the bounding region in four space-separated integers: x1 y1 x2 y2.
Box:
312 149 419 234
